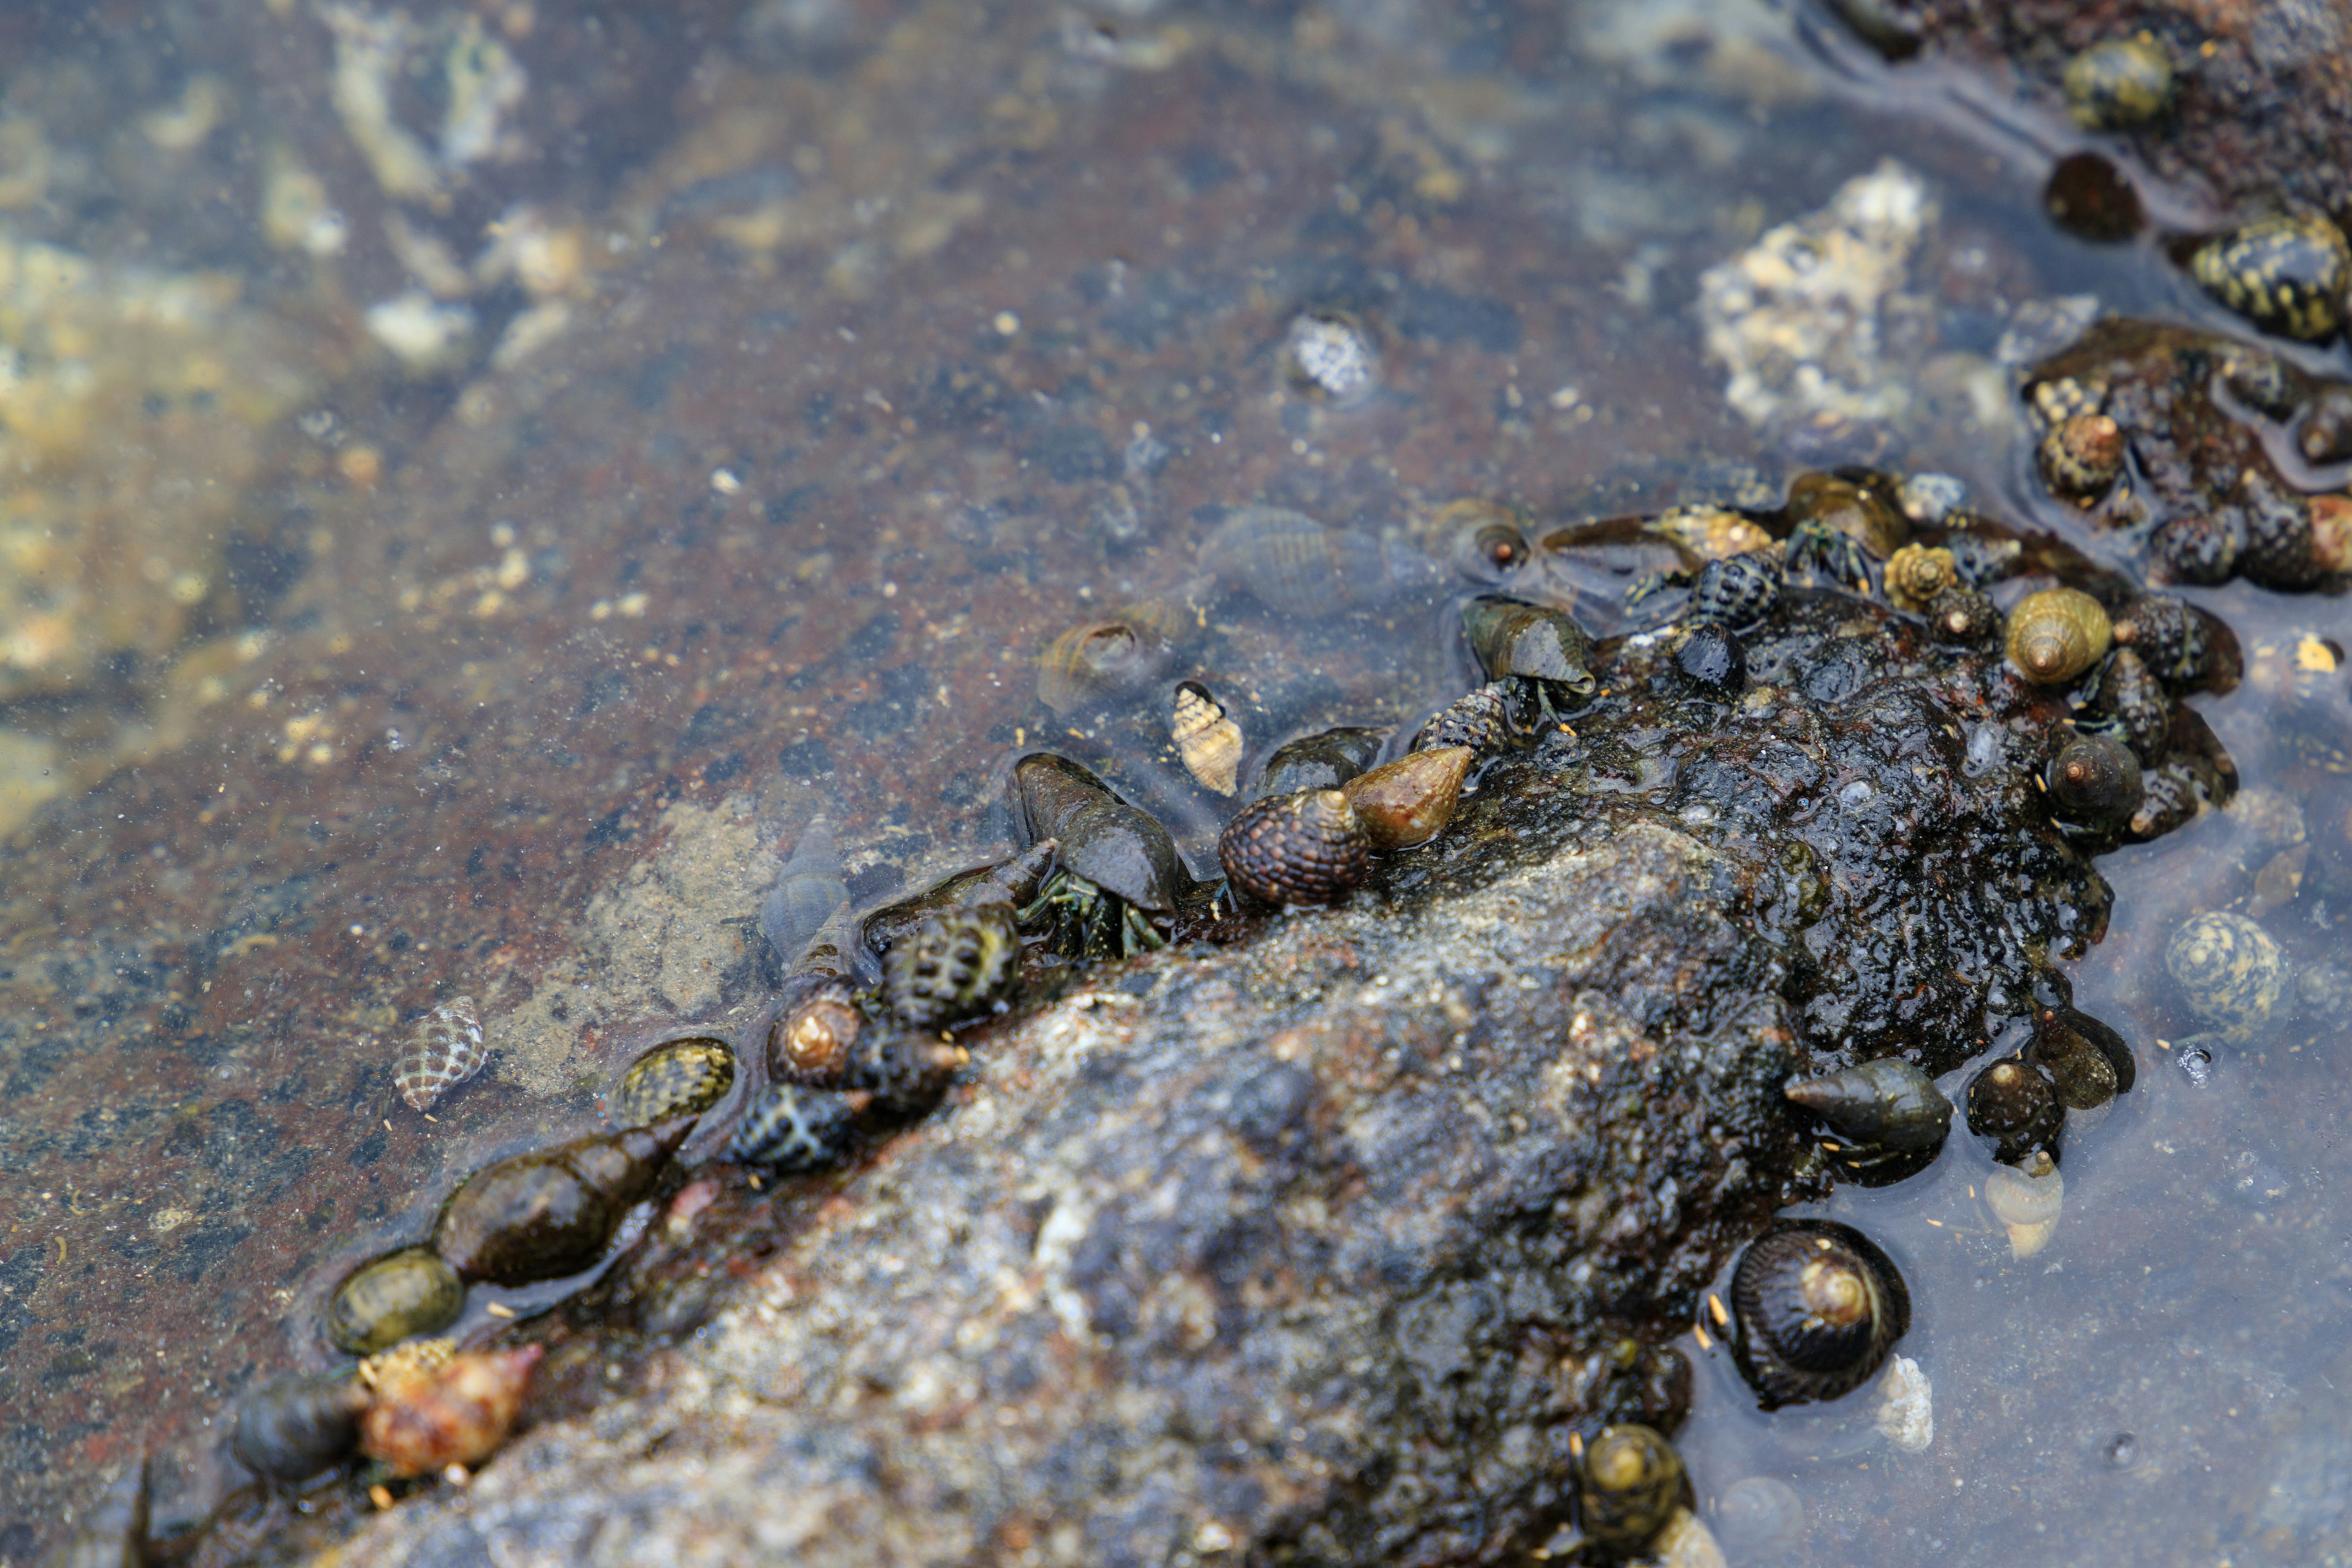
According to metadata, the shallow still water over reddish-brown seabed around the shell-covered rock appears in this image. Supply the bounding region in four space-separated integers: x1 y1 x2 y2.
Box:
0 0 2352 1563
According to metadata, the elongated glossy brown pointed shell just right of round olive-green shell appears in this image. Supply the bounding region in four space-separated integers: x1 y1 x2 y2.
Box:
433 1117 694 1286
